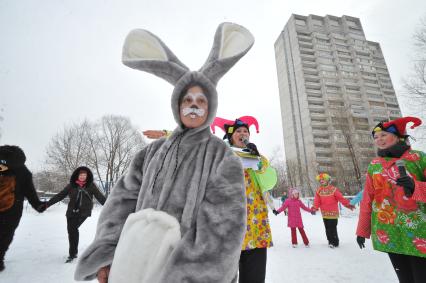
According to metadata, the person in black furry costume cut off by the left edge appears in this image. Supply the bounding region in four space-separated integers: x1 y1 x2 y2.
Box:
0 145 45 272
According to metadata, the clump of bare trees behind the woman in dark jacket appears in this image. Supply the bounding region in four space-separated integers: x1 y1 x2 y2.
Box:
44 115 145 195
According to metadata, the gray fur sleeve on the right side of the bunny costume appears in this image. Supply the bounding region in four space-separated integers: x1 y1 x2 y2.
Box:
159 153 246 282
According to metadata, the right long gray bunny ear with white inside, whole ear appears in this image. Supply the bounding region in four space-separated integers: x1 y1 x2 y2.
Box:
200 23 254 85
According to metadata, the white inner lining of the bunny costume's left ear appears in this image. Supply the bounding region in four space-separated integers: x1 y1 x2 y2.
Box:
123 29 168 61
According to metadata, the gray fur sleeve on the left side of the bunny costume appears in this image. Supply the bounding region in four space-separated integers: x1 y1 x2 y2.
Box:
74 147 147 280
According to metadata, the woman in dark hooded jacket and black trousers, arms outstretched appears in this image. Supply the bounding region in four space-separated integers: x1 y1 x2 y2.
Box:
47 166 105 262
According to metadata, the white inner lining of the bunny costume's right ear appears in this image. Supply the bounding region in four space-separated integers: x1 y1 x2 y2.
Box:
219 24 254 59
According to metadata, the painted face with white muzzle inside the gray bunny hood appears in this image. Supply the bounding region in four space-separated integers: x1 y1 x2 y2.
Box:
180 86 208 128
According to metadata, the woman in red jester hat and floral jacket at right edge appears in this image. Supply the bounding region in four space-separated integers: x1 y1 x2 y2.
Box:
356 117 426 283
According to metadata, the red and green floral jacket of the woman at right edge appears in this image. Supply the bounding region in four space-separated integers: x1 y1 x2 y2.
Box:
357 150 426 257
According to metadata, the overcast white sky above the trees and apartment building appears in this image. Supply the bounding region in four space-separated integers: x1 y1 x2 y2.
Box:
0 0 426 171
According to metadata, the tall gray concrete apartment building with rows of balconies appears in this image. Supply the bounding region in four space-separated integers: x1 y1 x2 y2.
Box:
275 14 401 194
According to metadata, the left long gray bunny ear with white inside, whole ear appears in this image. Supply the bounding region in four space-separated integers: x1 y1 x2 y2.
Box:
122 29 189 85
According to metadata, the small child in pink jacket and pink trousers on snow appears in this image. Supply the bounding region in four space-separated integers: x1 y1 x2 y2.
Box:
273 189 315 248
